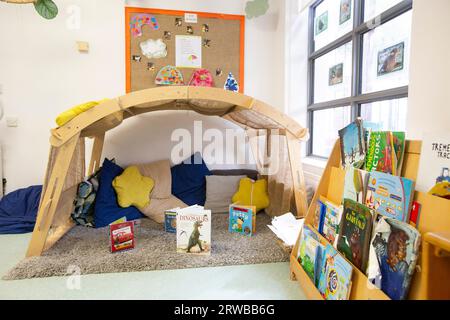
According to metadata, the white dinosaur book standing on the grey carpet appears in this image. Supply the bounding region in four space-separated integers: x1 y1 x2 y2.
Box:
177 206 211 255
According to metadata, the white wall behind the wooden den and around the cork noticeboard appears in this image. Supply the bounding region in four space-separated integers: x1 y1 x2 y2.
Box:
0 0 284 191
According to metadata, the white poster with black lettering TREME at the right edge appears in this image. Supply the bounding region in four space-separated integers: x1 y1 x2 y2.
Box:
417 131 450 192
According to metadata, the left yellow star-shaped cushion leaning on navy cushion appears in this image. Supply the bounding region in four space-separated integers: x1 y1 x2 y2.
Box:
113 166 155 210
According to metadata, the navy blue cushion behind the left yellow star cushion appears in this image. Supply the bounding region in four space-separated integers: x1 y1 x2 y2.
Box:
94 158 143 228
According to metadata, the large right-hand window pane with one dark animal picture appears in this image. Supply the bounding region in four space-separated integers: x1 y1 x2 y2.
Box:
362 11 412 93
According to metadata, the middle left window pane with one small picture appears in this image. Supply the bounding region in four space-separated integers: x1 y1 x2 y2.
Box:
314 42 352 103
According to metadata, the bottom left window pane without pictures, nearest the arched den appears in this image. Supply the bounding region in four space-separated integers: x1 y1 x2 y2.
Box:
312 107 351 157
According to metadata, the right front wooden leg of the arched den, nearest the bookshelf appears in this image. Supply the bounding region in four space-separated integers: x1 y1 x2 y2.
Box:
286 132 308 217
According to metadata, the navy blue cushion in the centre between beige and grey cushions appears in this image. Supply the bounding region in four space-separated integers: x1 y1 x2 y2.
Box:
170 153 211 206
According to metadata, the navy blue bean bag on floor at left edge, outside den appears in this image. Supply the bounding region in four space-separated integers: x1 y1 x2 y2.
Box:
0 185 42 234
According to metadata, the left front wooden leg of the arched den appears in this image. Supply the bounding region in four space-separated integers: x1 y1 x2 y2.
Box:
26 134 79 257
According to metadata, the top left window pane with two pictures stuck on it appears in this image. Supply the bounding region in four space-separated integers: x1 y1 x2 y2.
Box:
314 0 353 50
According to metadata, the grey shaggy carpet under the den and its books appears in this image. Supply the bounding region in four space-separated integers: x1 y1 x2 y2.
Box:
3 213 289 280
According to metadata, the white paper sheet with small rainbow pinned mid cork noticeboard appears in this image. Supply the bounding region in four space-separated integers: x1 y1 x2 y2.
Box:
175 35 202 68
